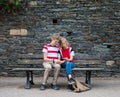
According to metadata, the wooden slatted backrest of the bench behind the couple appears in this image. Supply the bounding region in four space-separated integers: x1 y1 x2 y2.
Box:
17 54 101 67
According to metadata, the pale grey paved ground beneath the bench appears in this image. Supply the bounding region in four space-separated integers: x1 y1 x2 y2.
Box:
0 77 120 97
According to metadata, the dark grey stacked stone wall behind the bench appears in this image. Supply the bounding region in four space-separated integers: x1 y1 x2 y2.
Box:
0 0 120 77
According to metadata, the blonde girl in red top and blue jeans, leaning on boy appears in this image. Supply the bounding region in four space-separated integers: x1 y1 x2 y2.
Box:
59 37 75 84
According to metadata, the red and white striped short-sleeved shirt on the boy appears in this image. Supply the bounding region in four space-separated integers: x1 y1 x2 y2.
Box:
42 44 59 59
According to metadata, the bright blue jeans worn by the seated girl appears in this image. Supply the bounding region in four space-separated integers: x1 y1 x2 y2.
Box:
61 61 75 75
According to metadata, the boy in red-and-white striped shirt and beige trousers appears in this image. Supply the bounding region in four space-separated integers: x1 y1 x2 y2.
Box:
40 34 62 90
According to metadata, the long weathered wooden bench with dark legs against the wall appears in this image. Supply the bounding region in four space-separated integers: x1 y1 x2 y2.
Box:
12 54 104 89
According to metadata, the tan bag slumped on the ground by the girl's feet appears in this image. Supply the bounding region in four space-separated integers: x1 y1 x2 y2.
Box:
69 79 91 92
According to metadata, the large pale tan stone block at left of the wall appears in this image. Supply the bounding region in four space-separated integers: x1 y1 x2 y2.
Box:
10 29 28 36
